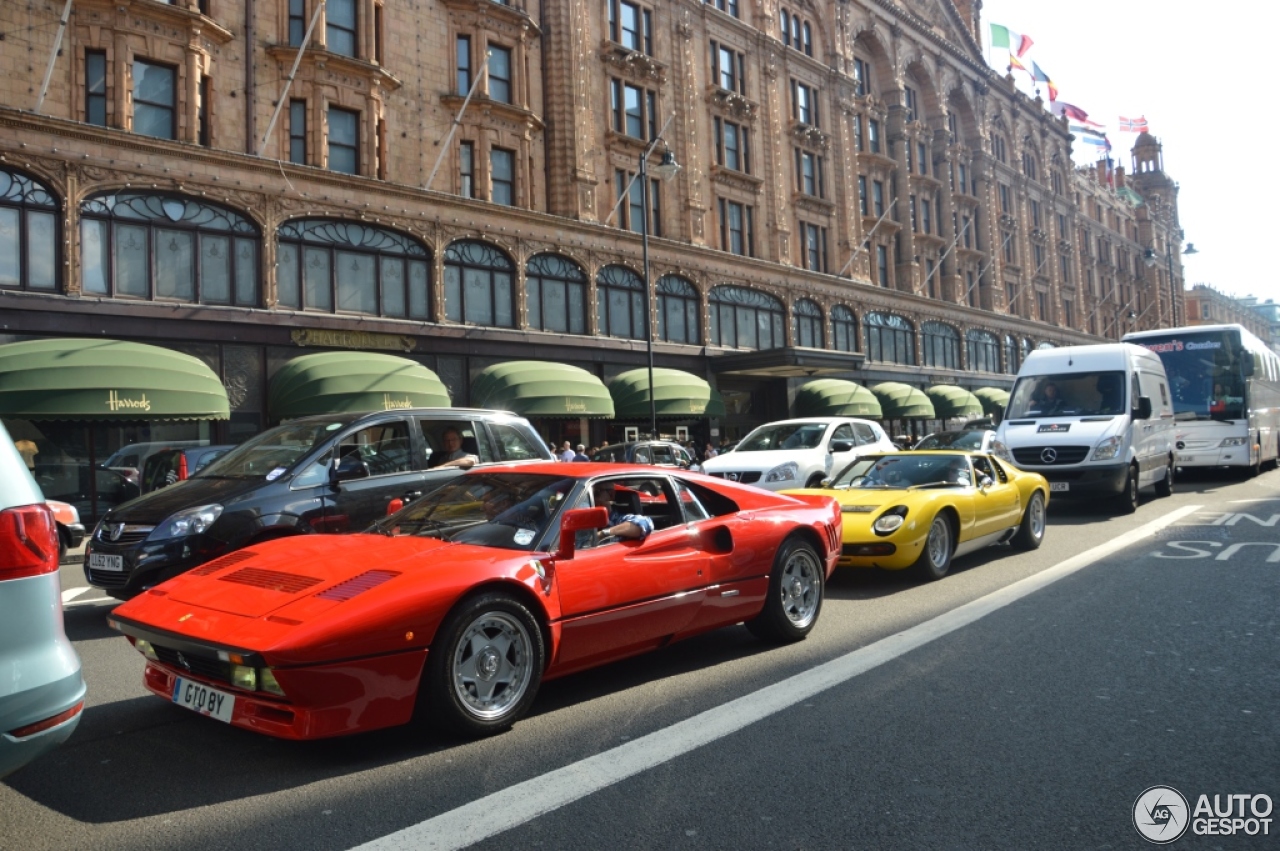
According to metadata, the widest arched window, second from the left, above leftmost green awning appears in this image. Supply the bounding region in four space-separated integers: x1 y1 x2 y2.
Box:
81 192 262 307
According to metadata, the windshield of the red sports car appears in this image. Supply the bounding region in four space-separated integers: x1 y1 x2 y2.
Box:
372 473 579 550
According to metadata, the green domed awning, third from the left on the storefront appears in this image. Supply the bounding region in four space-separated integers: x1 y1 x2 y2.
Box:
471 361 613 418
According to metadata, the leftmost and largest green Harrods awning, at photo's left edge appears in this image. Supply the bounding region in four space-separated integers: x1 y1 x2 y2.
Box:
0 339 230 420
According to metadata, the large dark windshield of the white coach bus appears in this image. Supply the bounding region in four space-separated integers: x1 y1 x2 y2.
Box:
1132 330 1247 421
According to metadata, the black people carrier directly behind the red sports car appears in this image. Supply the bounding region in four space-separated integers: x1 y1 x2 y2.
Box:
84 408 554 599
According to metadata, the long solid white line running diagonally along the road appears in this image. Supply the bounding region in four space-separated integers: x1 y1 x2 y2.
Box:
352 505 1203 851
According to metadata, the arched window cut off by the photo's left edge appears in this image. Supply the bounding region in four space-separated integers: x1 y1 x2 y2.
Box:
0 169 63 292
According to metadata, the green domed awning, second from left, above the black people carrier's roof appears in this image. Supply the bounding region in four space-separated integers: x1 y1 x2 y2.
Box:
266 352 452 420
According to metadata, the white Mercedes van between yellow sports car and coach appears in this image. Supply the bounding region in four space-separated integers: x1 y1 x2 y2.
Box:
997 343 1174 513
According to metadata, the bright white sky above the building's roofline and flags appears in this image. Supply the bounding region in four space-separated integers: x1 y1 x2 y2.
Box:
982 0 1280 302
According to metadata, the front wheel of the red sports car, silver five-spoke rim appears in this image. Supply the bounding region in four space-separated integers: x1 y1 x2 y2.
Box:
417 591 547 737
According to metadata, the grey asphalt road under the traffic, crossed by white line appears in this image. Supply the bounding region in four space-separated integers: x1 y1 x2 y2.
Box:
0 472 1280 851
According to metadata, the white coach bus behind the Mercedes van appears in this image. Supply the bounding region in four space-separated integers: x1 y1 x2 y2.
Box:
1124 325 1280 475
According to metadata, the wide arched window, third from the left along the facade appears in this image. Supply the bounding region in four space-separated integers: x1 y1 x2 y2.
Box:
275 219 431 319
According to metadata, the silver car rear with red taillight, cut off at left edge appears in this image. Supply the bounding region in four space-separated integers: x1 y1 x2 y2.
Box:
0 425 84 777
